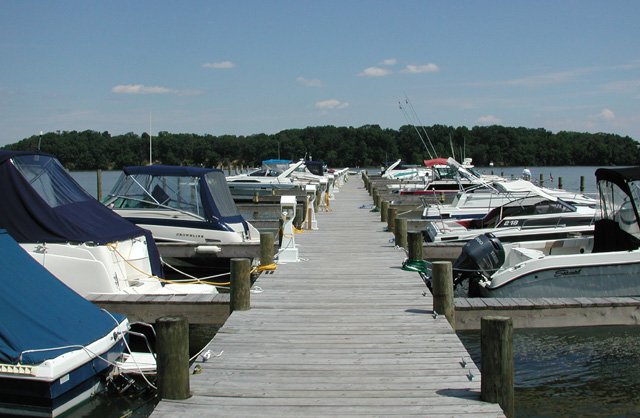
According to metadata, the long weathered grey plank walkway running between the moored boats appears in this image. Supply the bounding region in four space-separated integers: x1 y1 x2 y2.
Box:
152 176 504 418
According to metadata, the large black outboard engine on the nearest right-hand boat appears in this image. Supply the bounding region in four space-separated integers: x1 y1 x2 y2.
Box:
453 233 505 285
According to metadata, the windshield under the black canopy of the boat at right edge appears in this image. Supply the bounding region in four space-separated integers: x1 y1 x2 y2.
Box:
599 180 640 238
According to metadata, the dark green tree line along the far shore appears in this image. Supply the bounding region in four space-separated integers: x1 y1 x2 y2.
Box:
3 125 640 170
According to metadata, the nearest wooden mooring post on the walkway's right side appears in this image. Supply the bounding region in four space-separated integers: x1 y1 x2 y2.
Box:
480 316 515 418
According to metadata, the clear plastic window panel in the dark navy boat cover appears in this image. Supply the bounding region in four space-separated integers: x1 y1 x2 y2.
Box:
11 154 93 208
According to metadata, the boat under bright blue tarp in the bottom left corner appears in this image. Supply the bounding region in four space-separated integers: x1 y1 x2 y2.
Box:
0 230 129 416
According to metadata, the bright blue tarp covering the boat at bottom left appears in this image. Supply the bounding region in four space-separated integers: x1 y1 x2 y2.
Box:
0 229 124 364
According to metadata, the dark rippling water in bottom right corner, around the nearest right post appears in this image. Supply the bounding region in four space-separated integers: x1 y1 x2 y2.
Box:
458 327 640 417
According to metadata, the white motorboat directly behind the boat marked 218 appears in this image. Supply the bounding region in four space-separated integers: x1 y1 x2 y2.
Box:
422 179 598 220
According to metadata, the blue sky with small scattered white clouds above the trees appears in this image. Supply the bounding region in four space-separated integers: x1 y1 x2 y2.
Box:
0 0 640 145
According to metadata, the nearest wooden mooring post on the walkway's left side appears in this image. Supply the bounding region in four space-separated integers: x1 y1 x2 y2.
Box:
155 316 191 400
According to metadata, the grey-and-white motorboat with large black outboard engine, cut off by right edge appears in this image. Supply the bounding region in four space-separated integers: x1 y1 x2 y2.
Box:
454 167 640 298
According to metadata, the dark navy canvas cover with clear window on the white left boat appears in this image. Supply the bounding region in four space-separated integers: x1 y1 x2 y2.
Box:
0 150 163 277
